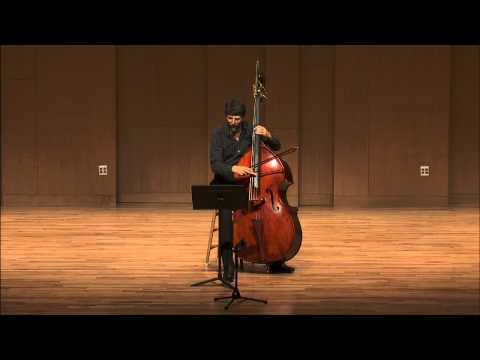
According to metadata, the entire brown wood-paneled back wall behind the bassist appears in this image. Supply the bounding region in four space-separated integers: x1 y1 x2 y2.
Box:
1 46 480 206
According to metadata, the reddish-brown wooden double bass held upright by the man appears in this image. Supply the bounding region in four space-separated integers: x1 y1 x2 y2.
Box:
233 60 302 264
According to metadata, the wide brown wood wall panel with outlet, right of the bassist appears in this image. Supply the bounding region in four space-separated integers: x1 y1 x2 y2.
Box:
334 46 450 205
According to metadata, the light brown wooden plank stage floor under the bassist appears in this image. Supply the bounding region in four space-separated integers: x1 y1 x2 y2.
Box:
1 205 480 315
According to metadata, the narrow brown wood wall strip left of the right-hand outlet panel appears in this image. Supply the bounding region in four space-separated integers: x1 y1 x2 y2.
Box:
299 46 335 206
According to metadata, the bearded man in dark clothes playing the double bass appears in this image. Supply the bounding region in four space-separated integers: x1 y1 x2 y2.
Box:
210 99 294 282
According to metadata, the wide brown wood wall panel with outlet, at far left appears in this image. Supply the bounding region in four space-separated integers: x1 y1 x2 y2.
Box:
2 46 116 205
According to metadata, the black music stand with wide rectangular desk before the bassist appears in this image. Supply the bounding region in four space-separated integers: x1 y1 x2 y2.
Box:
191 185 248 289
